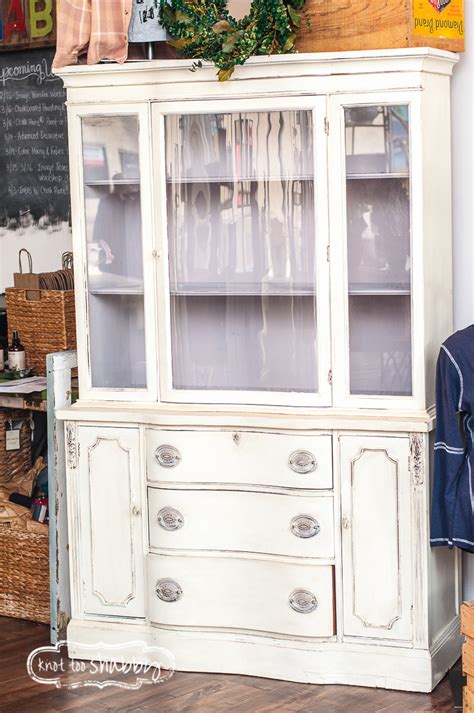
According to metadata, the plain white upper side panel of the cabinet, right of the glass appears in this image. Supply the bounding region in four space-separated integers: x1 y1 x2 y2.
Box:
422 75 453 407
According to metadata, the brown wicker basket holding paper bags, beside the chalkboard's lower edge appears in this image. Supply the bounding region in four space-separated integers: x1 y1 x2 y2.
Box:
5 287 76 376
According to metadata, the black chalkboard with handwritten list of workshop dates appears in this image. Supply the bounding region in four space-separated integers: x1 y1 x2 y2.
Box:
0 49 70 234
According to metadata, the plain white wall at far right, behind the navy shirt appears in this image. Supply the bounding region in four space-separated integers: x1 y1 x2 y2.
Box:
452 0 474 599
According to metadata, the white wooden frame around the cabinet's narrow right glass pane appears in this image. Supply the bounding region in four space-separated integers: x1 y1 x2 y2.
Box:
328 89 428 409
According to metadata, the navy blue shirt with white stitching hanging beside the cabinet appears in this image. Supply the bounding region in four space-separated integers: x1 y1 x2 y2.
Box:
431 325 474 552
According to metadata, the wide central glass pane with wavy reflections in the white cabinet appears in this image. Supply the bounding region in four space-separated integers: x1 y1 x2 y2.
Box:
165 111 318 392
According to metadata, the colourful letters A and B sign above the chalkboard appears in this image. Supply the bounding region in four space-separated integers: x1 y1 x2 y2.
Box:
0 0 56 52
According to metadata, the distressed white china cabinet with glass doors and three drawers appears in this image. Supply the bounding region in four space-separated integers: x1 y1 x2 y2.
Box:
54 49 461 691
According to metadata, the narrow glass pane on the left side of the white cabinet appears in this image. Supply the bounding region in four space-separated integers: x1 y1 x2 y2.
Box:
82 116 146 388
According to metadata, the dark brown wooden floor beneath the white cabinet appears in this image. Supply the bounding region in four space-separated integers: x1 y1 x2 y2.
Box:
0 617 454 713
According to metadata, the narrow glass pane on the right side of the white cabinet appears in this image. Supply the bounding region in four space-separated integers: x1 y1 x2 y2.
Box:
345 105 412 396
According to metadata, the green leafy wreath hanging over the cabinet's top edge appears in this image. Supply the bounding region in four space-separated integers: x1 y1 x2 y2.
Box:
160 0 305 81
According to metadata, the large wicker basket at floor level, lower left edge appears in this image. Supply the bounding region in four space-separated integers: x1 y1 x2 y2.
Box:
0 519 50 624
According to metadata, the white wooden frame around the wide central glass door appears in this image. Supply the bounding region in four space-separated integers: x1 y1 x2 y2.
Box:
152 92 332 407
